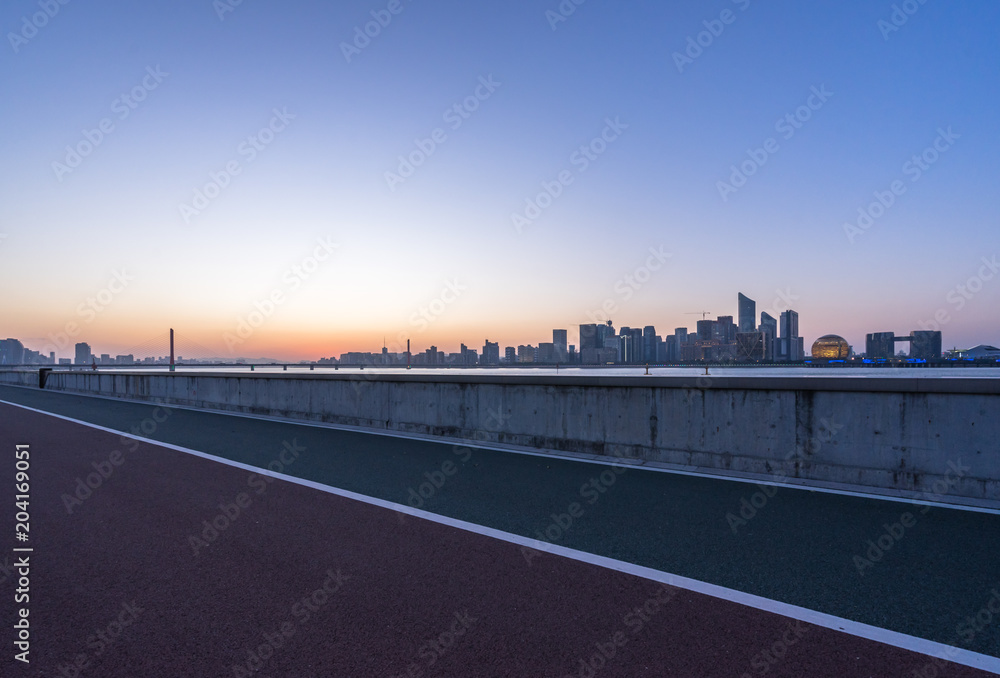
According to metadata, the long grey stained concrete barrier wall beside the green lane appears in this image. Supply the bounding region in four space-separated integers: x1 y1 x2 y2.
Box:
19 372 1000 501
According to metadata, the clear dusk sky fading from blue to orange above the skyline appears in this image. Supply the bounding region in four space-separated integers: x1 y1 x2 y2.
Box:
0 0 1000 360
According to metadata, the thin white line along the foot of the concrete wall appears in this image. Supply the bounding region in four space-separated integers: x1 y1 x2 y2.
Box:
0 384 1000 516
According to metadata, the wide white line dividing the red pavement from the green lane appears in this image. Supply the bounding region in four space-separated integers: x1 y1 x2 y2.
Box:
0 400 1000 674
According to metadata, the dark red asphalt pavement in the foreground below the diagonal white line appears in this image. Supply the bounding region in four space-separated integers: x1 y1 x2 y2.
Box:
0 405 992 678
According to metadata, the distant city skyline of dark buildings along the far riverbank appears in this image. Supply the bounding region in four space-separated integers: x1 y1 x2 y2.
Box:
0 293 1000 367
